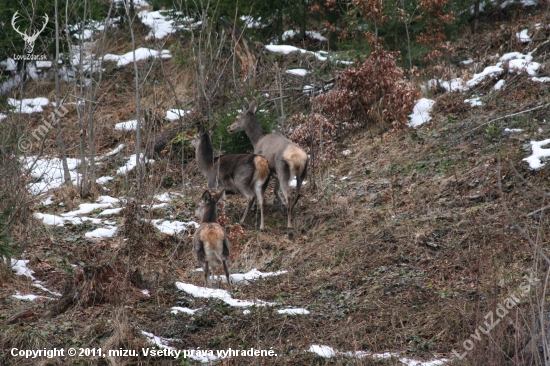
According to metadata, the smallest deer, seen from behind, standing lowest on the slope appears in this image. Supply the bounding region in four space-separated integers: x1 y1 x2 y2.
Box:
193 190 231 288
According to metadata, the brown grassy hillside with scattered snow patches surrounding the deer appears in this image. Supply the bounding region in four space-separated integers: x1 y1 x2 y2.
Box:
0 4 550 366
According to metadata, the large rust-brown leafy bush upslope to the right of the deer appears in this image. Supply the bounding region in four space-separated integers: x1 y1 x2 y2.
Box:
313 47 420 129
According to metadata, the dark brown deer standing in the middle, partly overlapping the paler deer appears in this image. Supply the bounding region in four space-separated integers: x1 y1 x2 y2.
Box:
191 122 271 230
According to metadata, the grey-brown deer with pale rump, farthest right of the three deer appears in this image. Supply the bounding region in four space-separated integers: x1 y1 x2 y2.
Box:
227 98 309 238
